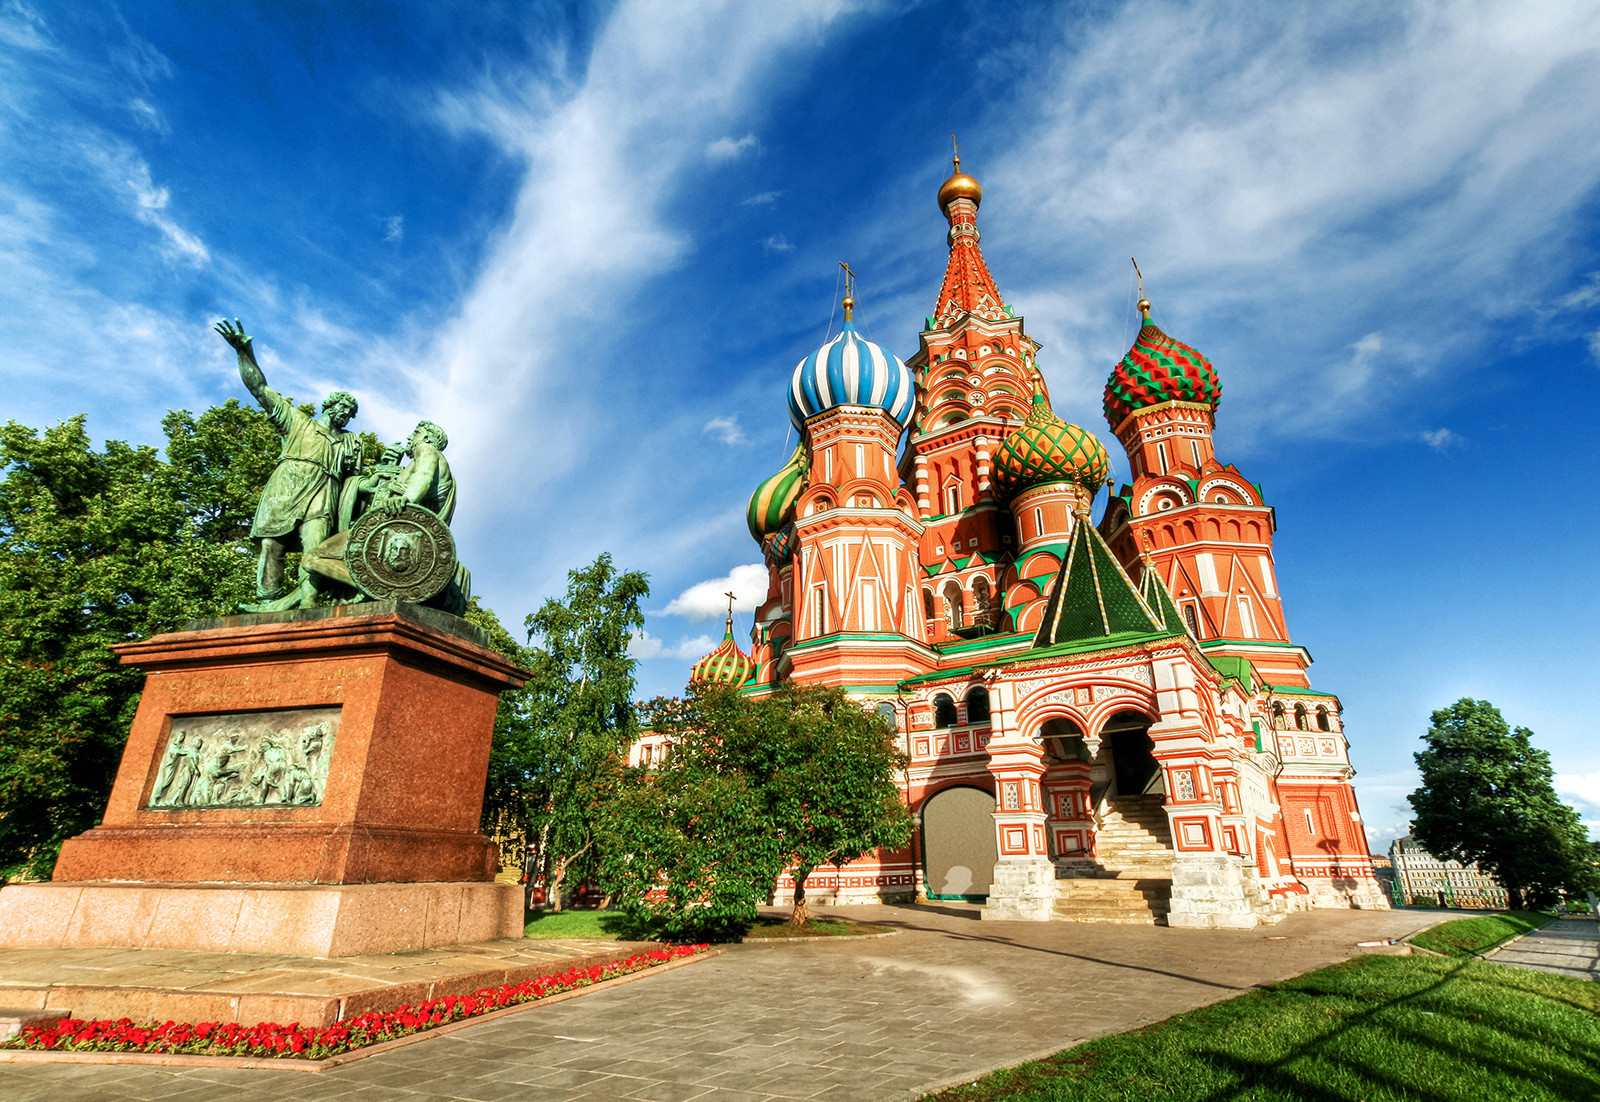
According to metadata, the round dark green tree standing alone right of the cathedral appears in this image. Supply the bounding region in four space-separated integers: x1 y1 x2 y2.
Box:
1411 699 1600 908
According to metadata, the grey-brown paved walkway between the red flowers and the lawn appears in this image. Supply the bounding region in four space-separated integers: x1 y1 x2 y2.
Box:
0 904 1438 1102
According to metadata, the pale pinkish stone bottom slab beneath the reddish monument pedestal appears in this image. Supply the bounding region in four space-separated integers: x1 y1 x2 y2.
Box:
0 881 523 956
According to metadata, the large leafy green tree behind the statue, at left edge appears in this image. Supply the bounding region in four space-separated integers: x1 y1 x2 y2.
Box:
0 401 277 875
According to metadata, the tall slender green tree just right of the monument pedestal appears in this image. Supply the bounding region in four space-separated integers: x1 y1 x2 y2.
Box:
521 555 650 910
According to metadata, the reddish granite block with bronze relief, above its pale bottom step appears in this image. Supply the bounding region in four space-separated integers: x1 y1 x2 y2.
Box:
54 601 525 882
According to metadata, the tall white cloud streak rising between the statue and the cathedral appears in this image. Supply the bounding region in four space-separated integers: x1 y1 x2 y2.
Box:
410 0 837 555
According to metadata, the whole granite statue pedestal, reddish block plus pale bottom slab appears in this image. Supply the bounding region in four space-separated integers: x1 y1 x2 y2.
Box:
0 601 526 955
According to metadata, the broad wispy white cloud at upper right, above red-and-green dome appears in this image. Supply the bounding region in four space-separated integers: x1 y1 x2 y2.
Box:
970 2 1600 441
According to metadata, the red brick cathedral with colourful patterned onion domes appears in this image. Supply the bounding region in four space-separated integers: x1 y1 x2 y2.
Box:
656 158 1387 928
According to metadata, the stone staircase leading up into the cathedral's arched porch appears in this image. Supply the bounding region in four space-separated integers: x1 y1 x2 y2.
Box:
1056 797 1173 926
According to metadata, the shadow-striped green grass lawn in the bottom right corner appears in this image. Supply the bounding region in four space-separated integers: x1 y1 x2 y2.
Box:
930 956 1600 1102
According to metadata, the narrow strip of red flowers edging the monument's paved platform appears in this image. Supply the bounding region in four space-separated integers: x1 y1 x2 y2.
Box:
3 945 709 1060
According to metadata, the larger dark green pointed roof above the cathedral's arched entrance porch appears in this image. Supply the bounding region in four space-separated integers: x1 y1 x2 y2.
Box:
1034 512 1182 648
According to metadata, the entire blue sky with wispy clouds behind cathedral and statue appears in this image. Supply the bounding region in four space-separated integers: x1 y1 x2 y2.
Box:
0 0 1600 848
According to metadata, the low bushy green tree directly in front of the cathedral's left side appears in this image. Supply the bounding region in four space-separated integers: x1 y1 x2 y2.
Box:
610 685 912 932
